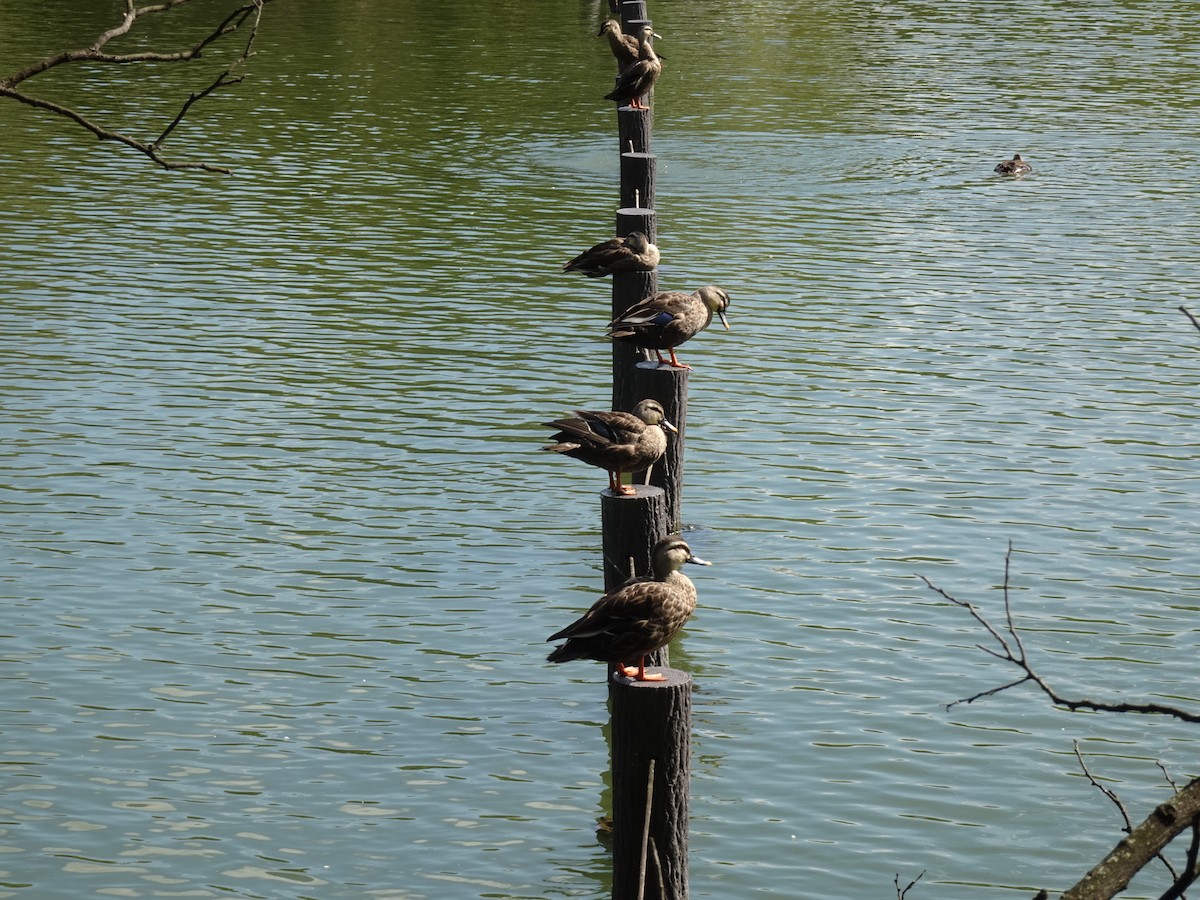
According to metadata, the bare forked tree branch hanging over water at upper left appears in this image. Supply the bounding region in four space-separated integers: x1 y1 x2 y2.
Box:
0 0 270 174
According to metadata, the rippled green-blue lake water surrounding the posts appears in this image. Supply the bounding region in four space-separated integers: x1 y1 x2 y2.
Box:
0 0 1200 900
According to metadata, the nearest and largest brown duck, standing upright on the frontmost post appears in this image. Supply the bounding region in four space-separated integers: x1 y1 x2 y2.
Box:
546 535 712 682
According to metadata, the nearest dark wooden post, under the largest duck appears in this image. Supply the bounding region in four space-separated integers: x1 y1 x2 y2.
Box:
608 668 691 900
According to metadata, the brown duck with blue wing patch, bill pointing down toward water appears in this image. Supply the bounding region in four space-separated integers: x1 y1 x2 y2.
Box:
608 284 730 368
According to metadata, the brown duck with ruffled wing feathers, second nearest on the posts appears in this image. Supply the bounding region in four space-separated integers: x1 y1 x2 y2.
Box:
542 400 679 497
